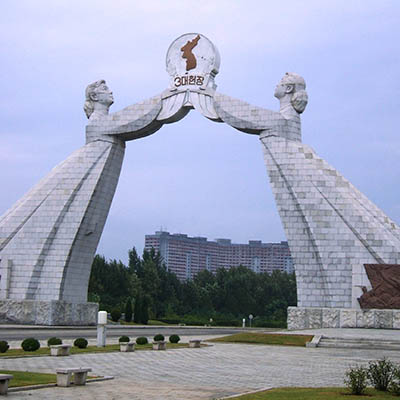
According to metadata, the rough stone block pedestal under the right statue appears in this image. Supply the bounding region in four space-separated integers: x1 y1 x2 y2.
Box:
287 307 400 330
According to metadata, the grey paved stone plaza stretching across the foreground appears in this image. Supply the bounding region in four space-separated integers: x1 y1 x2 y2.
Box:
1 329 400 400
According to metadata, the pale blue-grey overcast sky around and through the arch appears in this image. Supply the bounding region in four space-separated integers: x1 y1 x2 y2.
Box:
0 0 400 261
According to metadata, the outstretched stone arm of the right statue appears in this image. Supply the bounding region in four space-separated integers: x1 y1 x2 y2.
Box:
214 93 287 135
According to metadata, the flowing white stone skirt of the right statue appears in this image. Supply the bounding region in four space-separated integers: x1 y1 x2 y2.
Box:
261 135 400 308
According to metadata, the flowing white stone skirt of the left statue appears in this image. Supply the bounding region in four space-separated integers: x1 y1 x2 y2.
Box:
0 140 124 303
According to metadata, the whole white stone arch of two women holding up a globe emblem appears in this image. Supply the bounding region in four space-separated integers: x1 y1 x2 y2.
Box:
0 33 400 328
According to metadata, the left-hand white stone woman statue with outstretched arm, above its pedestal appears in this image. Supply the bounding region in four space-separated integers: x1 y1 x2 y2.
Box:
0 80 162 314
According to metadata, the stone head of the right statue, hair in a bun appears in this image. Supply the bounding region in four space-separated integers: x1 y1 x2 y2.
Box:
274 72 308 114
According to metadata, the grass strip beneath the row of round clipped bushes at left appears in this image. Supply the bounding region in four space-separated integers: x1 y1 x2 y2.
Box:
0 343 189 358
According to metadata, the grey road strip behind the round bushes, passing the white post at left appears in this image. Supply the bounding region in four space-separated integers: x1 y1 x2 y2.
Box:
0 325 242 341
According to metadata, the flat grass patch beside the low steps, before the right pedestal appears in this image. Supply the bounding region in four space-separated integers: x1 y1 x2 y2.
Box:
209 332 313 346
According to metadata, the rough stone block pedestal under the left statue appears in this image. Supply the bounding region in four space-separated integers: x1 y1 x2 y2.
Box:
0 300 99 326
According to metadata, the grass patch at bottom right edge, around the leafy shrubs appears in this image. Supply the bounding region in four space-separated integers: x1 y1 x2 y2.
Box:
235 388 398 400
